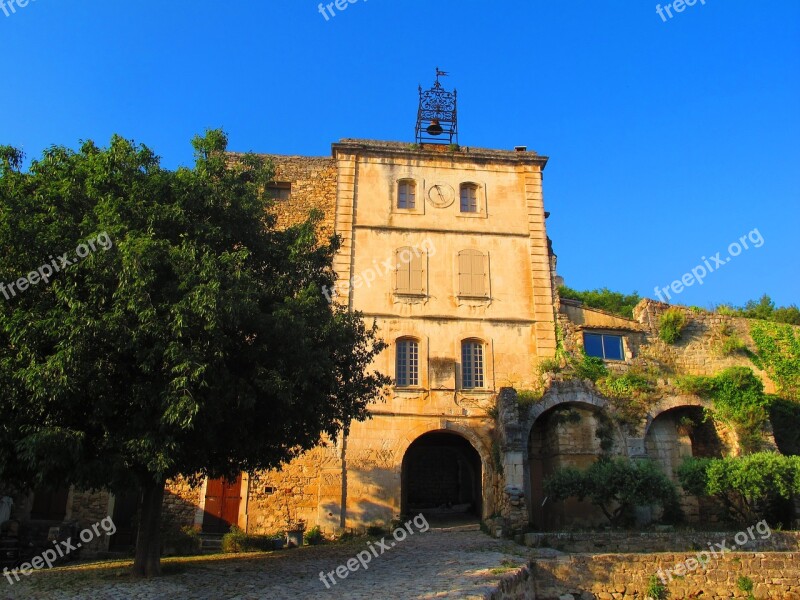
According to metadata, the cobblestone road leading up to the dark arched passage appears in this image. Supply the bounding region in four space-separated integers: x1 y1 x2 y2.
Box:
0 530 526 600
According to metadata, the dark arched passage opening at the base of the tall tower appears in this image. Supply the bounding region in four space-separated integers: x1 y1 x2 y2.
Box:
401 430 484 522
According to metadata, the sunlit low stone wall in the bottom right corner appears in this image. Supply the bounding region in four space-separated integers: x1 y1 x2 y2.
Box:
532 552 800 600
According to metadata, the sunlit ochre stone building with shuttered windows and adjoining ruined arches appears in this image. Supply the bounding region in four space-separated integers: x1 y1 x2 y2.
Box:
3 82 796 550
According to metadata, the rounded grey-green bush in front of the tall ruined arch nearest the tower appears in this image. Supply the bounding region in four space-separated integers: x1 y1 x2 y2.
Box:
544 458 680 526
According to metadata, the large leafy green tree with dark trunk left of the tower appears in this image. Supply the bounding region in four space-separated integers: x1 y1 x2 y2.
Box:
0 131 389 577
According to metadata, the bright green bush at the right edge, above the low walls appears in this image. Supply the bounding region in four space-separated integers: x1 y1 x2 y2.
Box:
678 452 800 525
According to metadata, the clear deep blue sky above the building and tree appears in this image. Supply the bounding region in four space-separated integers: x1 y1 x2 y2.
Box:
0 0 800 306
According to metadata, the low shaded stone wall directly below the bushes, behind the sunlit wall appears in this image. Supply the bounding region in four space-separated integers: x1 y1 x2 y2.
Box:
524 527 800 553
